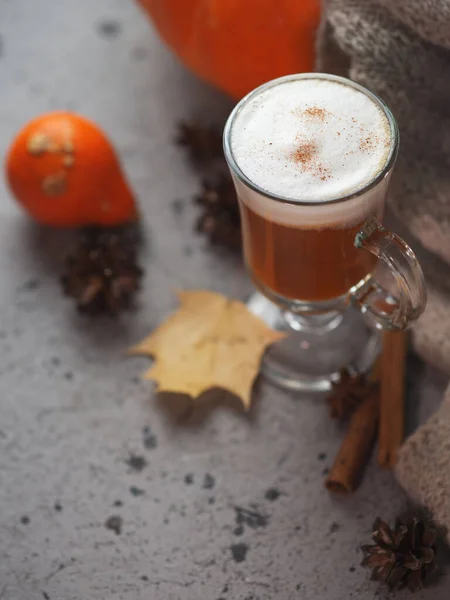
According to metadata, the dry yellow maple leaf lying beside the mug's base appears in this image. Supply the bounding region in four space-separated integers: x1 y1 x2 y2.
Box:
129 291 285 409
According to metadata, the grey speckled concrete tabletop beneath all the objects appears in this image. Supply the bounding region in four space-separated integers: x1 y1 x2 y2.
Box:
0 0 450 600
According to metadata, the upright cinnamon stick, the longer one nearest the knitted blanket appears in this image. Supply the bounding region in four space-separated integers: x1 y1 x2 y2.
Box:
378 331 407 468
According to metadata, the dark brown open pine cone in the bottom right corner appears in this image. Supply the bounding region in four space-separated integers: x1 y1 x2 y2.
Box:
361 517 437 592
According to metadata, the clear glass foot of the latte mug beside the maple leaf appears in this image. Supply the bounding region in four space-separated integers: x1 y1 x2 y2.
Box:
247 292 381 392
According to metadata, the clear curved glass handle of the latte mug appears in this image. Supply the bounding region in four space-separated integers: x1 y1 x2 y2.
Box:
352 218 427 330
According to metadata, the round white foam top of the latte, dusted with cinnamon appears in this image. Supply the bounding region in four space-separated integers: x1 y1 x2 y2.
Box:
230 78 394 203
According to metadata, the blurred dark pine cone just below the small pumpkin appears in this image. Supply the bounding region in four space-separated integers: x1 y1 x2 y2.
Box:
62 227 143 315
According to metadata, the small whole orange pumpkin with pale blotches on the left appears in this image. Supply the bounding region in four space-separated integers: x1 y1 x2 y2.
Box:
5 111 136 227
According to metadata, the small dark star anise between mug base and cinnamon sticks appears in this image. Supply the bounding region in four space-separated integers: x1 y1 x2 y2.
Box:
326 369 371 420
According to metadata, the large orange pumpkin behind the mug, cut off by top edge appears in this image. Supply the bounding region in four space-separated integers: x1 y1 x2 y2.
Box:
138 0 320 99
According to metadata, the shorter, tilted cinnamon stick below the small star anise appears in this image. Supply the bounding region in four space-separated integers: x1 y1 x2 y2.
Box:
325 392 379 494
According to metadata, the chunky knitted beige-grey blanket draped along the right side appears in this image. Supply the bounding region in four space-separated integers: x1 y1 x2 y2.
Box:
318 0 450 531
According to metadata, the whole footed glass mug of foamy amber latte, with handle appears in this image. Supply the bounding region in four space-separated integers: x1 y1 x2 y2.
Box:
224 73 426 390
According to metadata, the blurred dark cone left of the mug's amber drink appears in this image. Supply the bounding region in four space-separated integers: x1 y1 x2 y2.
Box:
196 176 241 250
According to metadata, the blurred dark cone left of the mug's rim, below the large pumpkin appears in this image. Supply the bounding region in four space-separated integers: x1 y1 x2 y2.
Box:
176 122 223 162
